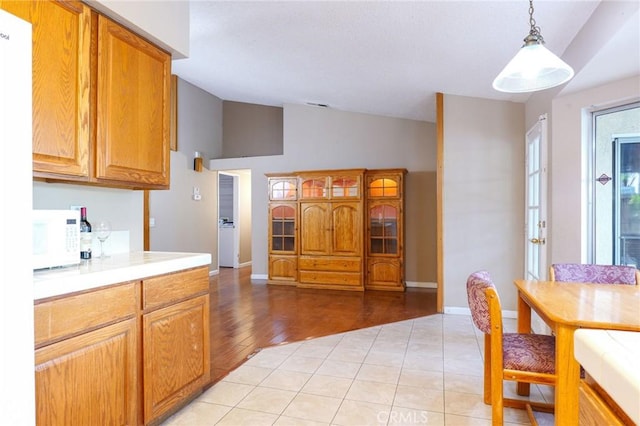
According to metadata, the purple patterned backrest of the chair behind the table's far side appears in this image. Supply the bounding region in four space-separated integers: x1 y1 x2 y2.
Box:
549 263 640 285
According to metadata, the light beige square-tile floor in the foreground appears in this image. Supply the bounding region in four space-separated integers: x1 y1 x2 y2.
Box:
163 315 553 426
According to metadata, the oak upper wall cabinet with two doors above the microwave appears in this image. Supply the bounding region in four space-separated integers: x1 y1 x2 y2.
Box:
0 0 171 189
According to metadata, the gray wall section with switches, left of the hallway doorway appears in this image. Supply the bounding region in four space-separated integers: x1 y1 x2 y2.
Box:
149 79 222 271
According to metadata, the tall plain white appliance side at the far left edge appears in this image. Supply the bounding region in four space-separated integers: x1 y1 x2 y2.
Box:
0 10 36 425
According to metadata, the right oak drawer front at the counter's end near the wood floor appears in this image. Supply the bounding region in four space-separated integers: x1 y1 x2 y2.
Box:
142 266 209 310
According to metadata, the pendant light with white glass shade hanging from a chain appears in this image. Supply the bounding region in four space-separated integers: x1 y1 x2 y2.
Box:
493 0 573 93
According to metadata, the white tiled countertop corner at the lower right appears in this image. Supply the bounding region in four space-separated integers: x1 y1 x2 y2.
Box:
574 329 640 425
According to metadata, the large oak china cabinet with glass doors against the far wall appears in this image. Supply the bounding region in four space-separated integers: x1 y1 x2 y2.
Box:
267 169 406 291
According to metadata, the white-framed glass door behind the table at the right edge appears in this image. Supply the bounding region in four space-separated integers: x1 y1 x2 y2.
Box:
590 102 640 268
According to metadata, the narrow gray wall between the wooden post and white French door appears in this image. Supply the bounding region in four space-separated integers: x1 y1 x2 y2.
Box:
443 95 525 312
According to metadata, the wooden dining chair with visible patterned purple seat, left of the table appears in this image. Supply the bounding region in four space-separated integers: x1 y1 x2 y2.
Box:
467 271 556 426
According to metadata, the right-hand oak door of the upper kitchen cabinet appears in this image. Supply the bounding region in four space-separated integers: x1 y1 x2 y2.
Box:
95 16 171 188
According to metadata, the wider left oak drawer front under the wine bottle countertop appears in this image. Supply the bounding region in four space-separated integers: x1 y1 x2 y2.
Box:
34 282 139 347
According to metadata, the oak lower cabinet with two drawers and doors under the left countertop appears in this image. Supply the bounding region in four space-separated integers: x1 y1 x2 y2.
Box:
34 266 210 426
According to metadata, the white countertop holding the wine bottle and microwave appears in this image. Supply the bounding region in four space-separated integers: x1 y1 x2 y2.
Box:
33 251 211 300
